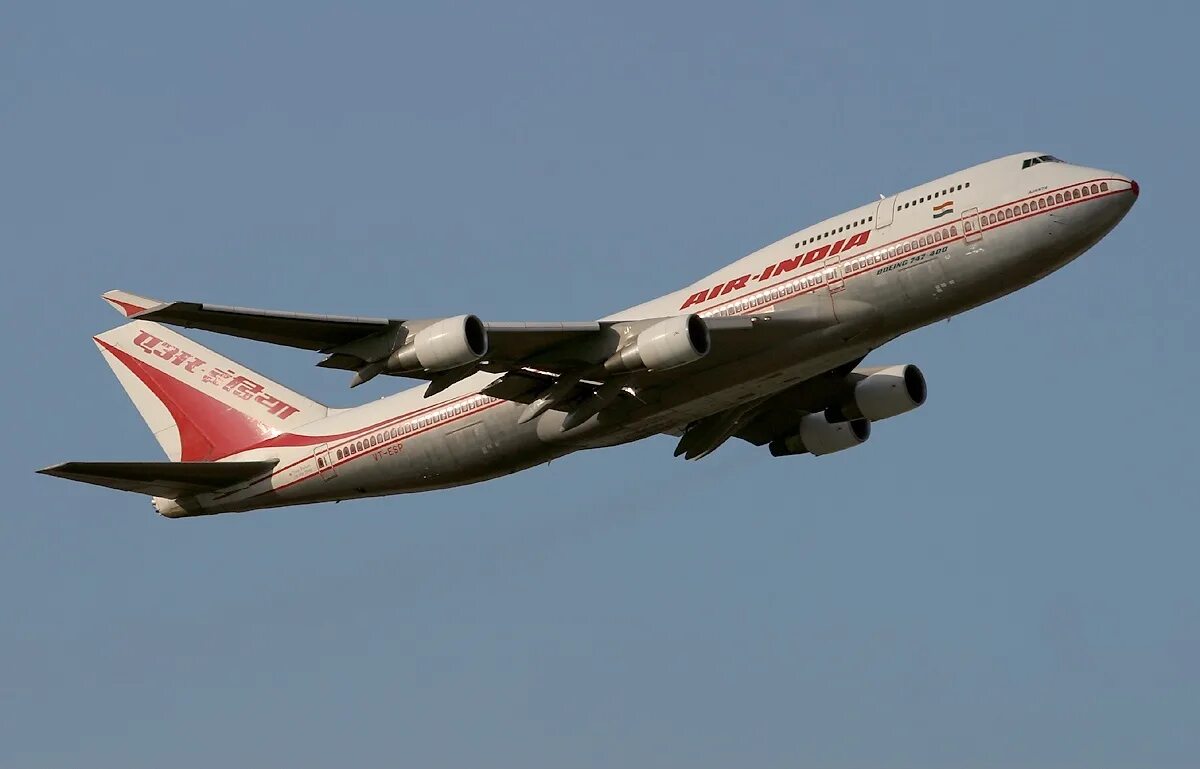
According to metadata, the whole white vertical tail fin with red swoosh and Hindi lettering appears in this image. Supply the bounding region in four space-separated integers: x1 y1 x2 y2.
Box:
94 320 329 462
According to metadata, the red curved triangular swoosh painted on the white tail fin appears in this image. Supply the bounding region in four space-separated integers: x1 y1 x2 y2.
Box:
96 338 278 462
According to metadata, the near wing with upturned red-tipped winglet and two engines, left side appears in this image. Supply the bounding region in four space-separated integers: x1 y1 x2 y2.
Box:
104 292 876 419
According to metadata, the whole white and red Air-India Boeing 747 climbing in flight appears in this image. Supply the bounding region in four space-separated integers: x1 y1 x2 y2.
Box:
38 152 1139 518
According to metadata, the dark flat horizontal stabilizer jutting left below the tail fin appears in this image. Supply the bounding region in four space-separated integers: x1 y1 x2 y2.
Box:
38 459 278 499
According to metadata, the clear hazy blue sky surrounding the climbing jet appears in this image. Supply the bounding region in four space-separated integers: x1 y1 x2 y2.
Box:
0 2 1200 769
